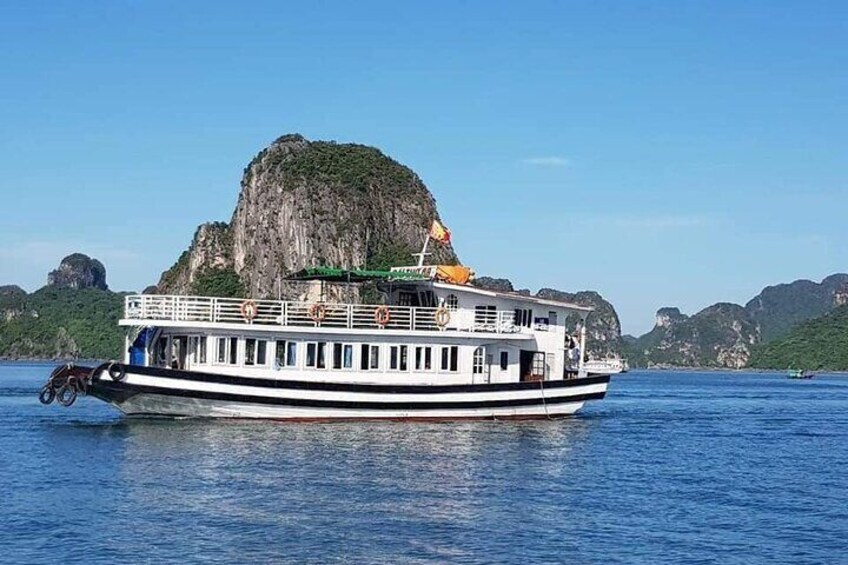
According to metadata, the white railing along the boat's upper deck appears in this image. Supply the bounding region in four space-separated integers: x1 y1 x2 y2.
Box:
124 294 522 333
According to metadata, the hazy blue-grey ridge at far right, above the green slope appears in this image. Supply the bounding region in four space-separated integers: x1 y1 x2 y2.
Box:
745 273 848 342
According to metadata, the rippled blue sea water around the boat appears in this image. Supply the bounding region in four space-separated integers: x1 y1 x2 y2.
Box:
0 363 848 564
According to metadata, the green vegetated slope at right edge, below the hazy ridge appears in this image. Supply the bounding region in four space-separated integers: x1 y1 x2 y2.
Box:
750 305 848 371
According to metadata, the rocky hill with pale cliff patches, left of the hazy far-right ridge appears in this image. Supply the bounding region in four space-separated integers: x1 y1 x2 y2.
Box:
628 303 760 369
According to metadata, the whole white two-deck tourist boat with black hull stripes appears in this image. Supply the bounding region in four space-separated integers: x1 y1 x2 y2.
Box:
41 260 610 420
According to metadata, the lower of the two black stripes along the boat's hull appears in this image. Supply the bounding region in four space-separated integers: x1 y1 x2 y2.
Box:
91 381 606 410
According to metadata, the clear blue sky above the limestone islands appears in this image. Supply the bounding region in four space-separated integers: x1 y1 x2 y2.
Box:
0 0 848 335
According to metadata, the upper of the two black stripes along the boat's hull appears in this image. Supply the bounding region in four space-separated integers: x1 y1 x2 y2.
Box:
109 365 610 394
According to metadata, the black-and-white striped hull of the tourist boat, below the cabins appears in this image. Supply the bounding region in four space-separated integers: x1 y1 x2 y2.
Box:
89 365 609 420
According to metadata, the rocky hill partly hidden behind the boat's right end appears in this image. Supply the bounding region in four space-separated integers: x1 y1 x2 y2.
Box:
536 288 624 359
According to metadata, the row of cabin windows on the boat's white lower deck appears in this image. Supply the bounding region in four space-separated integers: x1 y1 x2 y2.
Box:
175 336 464 373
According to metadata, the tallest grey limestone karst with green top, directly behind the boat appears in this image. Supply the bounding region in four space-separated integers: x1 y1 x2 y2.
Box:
158 135 457 297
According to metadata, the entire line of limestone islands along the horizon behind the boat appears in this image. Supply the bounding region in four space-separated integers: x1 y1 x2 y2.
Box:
0 134 848 370
